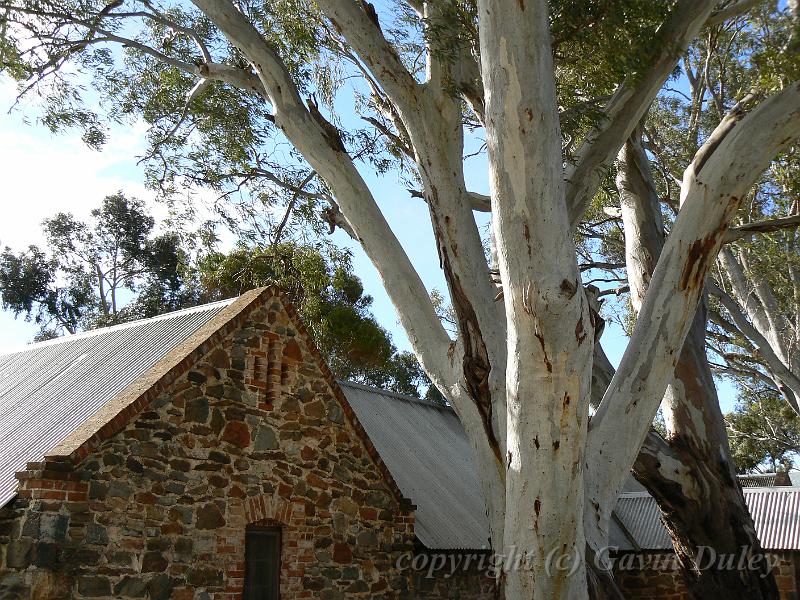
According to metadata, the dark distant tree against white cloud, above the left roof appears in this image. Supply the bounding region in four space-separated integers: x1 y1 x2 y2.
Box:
0 192 190 339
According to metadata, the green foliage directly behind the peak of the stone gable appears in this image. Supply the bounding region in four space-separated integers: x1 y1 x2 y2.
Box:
197 242 430 395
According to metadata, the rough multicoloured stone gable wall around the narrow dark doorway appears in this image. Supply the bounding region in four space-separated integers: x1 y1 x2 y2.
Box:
0 298 413 600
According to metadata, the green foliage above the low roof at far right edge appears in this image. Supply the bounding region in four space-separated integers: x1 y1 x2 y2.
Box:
725 387 800 472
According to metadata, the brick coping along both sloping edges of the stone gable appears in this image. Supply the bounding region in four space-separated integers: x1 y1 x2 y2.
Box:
27 286 415 514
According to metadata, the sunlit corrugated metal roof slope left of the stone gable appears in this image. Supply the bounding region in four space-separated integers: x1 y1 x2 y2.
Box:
0 300 232 506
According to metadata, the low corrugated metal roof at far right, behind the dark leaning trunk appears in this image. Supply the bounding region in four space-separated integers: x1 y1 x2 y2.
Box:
612 486 800 550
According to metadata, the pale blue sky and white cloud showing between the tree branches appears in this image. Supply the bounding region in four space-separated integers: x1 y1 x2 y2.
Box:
0 68 735 411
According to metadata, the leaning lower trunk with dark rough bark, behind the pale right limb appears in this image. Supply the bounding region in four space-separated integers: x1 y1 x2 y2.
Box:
634 306 779 600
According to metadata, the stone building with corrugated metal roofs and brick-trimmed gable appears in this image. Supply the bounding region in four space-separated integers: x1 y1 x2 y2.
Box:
0 288 800 600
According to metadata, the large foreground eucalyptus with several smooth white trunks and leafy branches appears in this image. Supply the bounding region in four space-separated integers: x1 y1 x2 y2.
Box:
0 0 800 600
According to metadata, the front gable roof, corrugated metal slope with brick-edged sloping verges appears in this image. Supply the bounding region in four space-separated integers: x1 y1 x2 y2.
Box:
0 286 410 509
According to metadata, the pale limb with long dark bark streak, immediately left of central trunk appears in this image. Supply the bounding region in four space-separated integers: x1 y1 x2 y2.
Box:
312 0 506 547
